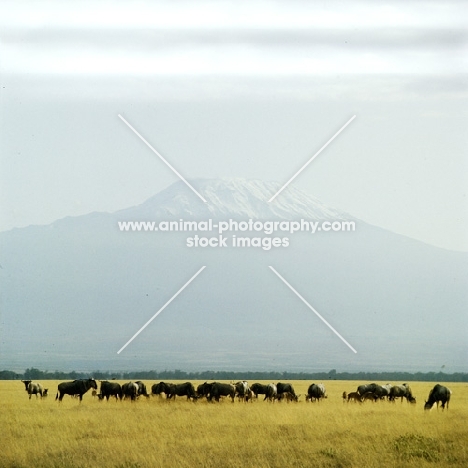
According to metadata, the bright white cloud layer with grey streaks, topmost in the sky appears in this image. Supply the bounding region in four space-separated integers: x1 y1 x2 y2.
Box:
0 1 467 76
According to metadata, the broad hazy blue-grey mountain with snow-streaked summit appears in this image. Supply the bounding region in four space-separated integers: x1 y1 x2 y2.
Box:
0 179 468 372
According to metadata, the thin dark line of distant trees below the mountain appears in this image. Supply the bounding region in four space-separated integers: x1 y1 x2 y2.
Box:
0 367 468 382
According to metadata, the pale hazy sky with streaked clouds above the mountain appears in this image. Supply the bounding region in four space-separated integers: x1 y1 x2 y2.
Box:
0 1 468 251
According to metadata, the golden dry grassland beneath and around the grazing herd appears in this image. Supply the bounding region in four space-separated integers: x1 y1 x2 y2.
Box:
0 381 468 468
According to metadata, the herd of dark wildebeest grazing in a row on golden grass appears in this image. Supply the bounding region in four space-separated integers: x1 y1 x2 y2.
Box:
22 378 452 410
